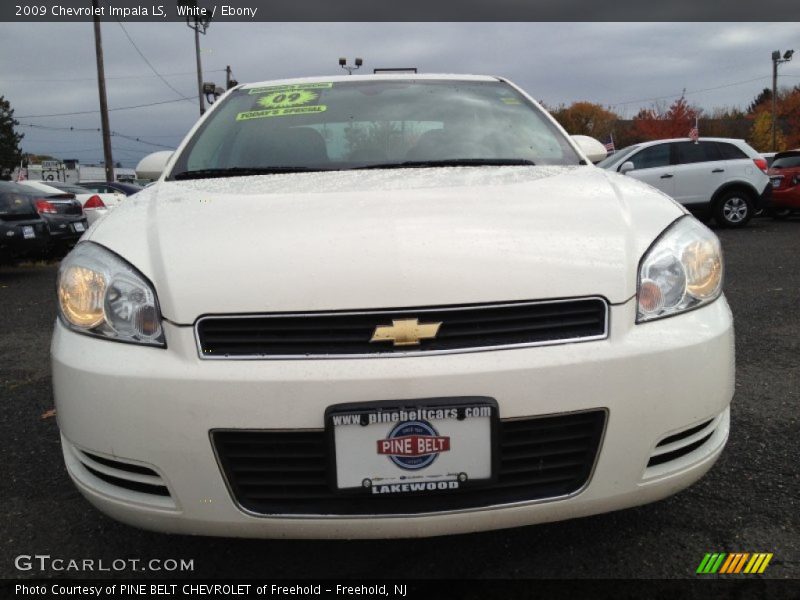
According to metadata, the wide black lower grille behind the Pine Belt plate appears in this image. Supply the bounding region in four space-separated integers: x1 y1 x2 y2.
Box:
211 409 606 515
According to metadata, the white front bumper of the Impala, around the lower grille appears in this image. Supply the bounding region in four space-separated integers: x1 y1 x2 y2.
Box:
52 298 734 538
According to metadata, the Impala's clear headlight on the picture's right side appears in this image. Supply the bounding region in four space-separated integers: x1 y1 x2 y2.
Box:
636 216 723 323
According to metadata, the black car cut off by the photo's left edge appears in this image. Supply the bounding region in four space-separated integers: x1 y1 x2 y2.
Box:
0 181 48 263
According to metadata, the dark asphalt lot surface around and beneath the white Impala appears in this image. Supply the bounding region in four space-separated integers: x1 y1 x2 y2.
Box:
0 218 800 579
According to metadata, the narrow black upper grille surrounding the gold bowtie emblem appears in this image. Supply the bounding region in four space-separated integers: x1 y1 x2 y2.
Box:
196 298 608 358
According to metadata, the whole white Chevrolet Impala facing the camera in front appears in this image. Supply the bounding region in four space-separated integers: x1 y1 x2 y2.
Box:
52 75 734 538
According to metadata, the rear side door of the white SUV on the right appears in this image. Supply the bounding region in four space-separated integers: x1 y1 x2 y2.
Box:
674 142 730 206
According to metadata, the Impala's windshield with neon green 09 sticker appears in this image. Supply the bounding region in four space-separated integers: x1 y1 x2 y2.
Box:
171 77 580 179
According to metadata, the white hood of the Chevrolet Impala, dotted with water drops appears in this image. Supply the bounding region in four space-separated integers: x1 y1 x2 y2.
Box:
87 167 685 324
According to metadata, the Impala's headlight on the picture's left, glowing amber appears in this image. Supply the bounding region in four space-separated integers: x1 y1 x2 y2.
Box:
58 242 166 347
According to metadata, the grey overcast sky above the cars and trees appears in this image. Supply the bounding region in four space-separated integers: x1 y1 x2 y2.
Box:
0 22 800 167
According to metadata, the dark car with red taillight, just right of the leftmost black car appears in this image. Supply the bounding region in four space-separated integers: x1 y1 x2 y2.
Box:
0 181 88 256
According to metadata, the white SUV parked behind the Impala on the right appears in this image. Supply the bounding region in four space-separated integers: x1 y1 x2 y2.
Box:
598 138 771 227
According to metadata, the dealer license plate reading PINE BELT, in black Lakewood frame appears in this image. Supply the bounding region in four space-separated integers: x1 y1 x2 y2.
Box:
325 397 498 495
